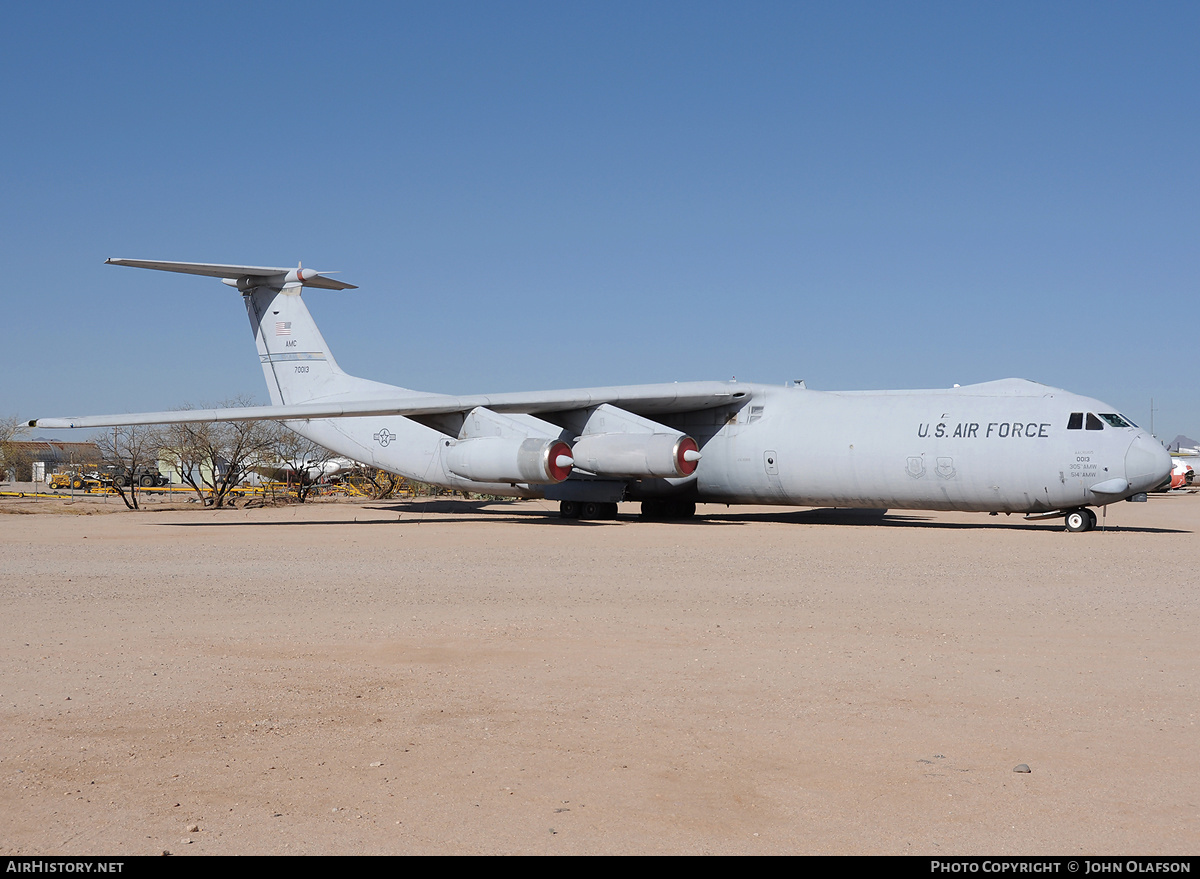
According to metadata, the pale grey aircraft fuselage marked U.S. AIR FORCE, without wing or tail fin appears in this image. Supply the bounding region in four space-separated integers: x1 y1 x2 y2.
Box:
285 379 1170 513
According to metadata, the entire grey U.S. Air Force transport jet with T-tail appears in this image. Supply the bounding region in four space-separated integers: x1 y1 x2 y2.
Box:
30 259 1171 531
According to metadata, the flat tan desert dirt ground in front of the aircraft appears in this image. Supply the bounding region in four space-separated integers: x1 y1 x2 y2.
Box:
0 495 1200 855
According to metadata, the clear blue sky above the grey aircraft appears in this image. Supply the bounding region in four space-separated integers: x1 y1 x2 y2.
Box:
0 2 1200 440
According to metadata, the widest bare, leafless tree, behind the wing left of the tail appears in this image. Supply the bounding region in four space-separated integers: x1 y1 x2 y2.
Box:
154 396 276 507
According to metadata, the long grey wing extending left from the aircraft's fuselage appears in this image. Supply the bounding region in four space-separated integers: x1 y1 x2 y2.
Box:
29 382 751 429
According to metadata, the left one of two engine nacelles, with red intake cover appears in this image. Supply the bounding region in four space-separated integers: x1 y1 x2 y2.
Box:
445 436 575 485
